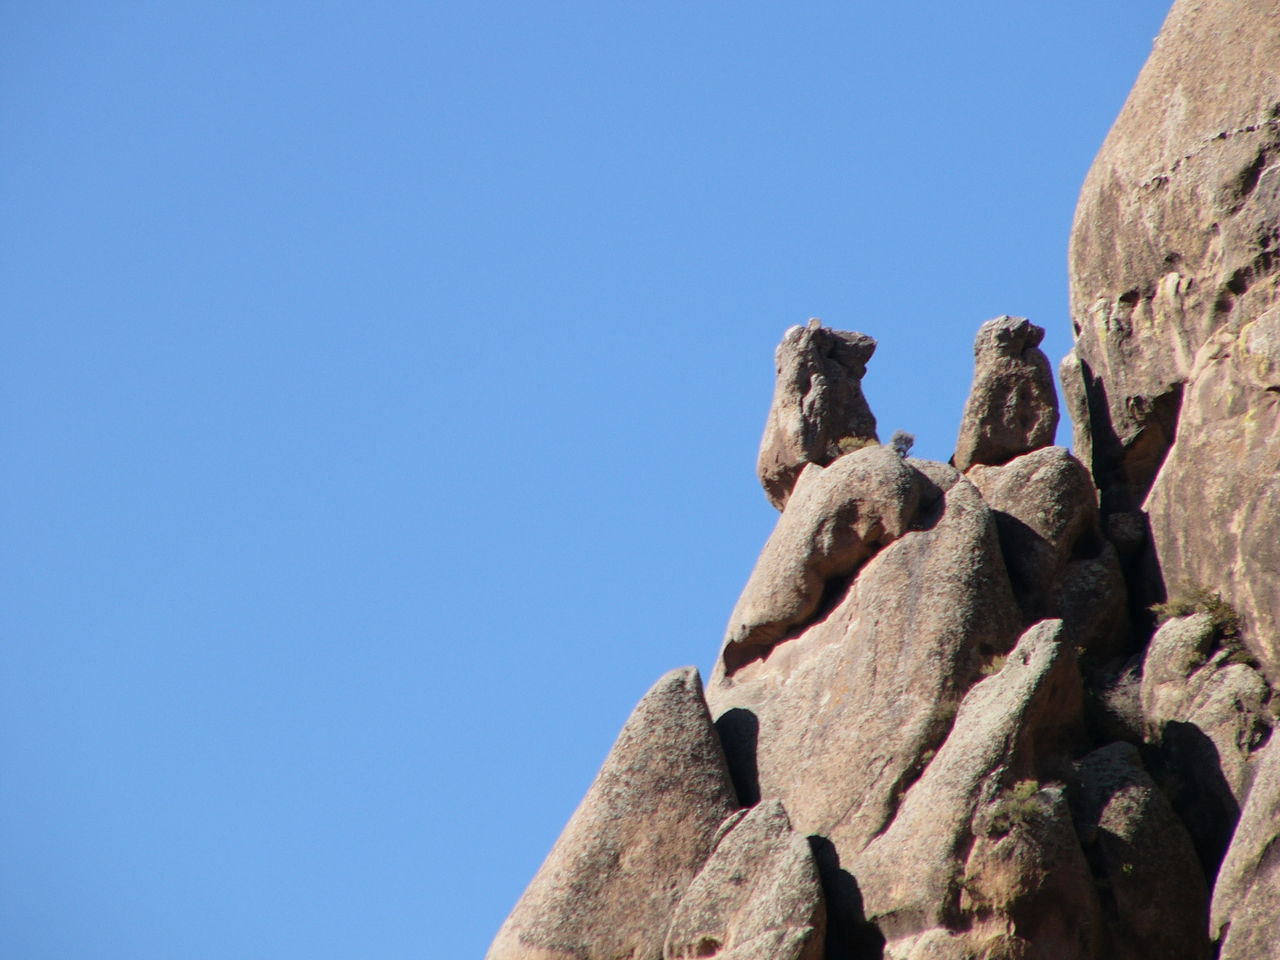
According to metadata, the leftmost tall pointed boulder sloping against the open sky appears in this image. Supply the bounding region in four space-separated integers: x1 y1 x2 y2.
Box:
486 667 737 960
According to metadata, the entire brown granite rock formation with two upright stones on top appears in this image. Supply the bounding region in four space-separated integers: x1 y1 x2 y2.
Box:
489 0 1280 960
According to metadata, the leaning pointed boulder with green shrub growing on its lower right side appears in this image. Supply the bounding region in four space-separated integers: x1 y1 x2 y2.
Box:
851 621 1098 960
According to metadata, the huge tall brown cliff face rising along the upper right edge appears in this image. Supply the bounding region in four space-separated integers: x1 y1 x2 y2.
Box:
1062 0 1280 677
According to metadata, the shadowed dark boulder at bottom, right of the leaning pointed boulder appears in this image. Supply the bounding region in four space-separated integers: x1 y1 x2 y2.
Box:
1073 742 1211 960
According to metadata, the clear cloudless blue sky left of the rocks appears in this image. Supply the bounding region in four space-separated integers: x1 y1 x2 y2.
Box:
0 0 1167 960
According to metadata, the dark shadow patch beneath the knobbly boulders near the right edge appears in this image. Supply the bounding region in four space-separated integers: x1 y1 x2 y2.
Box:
1143 721 1240 886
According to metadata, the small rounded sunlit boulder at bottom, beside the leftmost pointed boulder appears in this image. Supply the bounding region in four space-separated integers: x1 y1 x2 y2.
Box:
663 800 827 960
